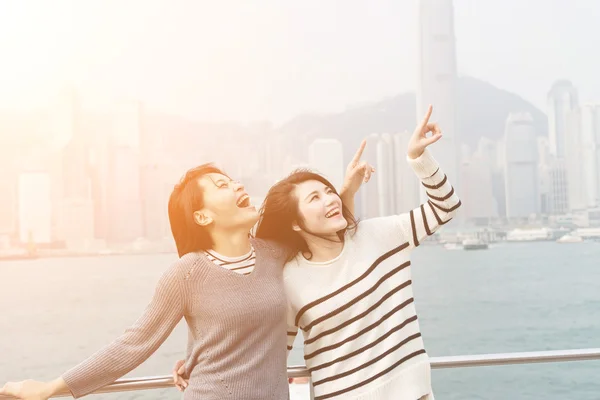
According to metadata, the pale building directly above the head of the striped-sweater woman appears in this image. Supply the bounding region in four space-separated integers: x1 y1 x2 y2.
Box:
308 139 345 191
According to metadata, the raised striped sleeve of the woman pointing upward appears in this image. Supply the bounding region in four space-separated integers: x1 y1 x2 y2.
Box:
372 149 462 248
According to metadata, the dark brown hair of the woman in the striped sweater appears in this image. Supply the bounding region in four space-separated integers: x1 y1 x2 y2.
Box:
256 169 358 261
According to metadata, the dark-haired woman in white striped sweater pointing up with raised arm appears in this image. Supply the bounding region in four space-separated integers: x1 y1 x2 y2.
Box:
256 107 461 400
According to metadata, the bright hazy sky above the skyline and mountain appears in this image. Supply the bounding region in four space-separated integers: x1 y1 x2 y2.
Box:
0 0 600 122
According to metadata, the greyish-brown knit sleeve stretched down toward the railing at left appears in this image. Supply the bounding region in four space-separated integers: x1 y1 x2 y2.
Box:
62 266 184 398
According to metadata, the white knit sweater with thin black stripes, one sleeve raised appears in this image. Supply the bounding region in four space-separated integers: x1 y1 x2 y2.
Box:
284 150 461 400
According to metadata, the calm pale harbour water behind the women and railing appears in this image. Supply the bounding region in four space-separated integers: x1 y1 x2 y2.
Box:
0 242 600 400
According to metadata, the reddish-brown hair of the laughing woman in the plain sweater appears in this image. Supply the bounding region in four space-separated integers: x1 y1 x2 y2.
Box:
169 164 227 257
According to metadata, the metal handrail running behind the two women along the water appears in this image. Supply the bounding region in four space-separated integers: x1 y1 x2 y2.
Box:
0 348 600 399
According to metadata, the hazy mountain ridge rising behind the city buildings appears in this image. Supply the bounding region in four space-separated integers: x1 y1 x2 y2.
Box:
279 77 548 161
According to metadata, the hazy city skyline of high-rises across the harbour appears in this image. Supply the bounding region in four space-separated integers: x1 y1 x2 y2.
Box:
0 0 600 253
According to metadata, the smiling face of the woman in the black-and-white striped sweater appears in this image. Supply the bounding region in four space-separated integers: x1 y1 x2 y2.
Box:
293 180 348 237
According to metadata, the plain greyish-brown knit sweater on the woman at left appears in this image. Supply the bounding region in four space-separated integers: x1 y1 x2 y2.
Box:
63 239 289 400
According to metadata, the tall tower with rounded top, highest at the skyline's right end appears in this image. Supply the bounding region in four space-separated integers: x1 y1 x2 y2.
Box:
547 80 578 159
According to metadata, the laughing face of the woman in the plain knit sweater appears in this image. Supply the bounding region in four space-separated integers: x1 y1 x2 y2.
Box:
194 173 258 230
